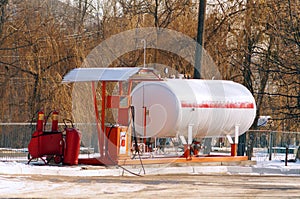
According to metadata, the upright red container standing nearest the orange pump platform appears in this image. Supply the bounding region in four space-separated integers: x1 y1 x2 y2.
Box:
63 120 81 165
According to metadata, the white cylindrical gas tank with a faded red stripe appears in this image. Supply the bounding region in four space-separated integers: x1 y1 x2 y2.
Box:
131 79 256 137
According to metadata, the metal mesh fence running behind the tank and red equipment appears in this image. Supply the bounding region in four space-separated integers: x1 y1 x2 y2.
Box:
0 123 300 161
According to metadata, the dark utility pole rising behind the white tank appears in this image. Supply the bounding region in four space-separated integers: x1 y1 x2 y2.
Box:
194 0 206 79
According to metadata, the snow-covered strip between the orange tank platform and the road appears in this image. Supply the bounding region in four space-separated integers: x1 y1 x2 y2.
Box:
0 157 300 176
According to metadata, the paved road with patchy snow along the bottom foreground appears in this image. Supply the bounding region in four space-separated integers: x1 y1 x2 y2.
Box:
0 175 300 199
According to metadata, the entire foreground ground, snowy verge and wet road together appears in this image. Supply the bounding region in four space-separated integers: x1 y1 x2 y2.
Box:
0 160 300 198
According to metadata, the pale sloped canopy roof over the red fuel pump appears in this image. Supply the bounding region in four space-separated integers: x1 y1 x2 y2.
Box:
62 67 143 83
